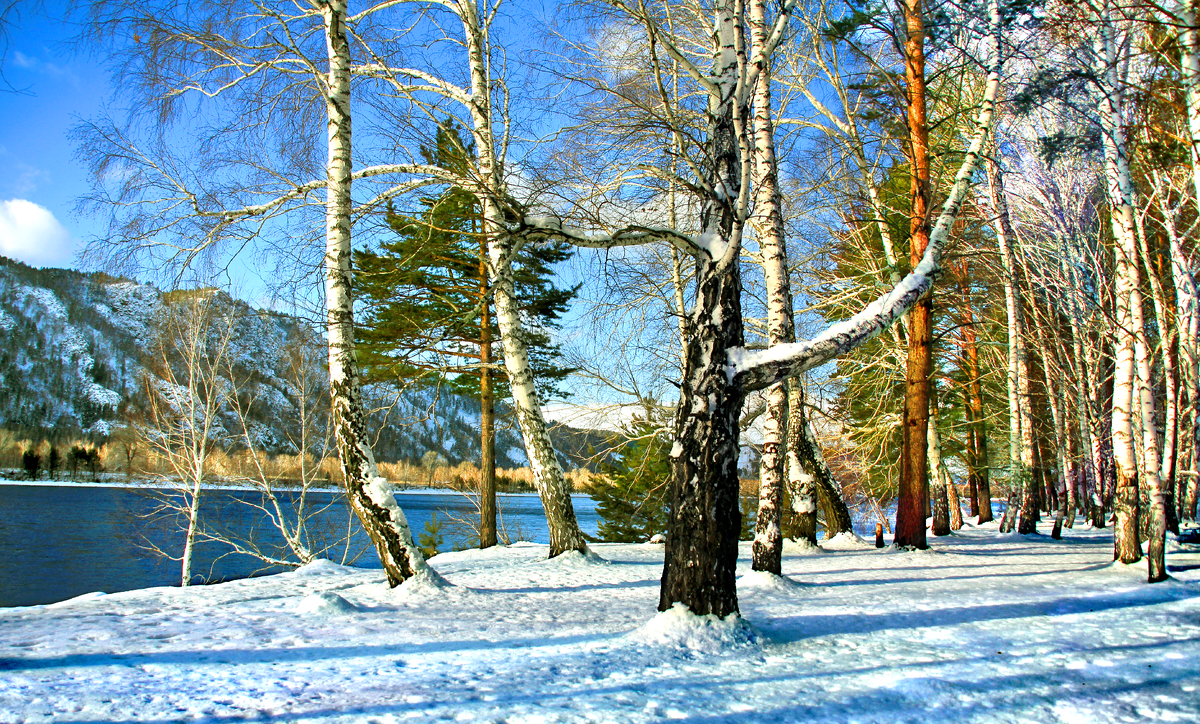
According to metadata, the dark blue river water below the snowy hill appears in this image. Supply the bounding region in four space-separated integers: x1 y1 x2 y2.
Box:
0 485 599 606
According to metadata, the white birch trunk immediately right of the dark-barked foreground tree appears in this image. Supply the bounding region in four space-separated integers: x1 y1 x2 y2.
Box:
748 0 796 575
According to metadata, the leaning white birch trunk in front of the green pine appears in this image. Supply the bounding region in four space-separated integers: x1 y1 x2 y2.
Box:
454 0 588 558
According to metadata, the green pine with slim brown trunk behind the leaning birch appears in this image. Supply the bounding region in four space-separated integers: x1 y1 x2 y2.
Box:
354 122 578 548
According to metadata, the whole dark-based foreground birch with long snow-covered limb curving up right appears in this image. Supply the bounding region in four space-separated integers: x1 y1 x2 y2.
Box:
512 0 1000 617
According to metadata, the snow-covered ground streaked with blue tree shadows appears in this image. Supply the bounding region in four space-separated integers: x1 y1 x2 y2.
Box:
0 523 1200 724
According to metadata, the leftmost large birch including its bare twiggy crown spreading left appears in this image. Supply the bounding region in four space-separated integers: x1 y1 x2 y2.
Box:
80 0 442 586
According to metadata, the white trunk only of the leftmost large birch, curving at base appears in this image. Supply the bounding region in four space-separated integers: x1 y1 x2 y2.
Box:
323 0 437 586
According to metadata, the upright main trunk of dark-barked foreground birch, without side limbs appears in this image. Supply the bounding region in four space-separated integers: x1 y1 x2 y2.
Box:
659 0 749 618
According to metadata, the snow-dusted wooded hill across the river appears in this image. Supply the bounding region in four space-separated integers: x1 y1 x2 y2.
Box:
0 257 602 467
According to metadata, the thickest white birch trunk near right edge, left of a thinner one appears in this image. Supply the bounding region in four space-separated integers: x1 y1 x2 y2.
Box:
1096 9 1141 563
